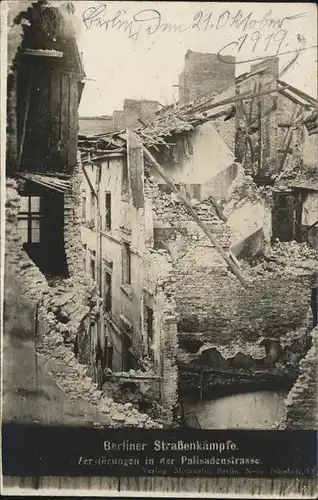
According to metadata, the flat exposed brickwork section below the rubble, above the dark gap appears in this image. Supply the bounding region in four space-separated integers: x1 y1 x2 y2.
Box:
175 261 310 343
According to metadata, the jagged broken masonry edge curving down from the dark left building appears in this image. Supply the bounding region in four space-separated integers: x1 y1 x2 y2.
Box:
4 179 161 427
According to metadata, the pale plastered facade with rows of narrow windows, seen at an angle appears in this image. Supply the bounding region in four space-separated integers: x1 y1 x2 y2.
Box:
78 150 177 422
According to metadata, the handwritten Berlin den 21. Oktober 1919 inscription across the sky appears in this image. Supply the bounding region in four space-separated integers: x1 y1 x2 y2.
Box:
82 3 306 62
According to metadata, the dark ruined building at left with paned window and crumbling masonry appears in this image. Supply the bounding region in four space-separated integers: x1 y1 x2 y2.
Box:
4 0 161 427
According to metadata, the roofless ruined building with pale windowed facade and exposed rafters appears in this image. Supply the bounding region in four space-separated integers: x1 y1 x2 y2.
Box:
79 53 316 427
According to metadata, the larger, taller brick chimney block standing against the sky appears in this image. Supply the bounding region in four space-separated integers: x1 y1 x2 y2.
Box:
179 50 235 105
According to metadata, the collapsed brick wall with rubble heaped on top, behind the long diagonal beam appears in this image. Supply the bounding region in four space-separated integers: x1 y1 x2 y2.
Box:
145 175 316 404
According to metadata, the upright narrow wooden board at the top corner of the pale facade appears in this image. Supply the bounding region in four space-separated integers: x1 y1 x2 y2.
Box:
127 129 144 208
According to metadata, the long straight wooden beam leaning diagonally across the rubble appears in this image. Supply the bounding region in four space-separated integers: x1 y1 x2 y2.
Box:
143 146 248 288
